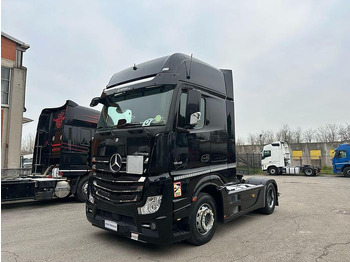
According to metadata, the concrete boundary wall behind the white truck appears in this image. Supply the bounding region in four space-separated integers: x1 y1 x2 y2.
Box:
236 141 350 167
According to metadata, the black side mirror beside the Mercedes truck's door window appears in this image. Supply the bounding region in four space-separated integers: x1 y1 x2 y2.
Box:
186 89 201 126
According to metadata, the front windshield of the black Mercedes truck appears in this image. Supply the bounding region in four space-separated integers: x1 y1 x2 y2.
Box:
98 85 174 128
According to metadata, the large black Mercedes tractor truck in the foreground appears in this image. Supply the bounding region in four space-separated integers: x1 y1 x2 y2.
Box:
86 54 278 245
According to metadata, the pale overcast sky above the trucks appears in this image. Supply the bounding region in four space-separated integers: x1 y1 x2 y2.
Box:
1 0 350 142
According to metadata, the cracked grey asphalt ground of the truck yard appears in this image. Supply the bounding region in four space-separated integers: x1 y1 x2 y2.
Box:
1 175 350 262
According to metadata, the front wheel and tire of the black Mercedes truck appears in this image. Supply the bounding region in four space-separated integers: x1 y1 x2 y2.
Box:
188 193 217 246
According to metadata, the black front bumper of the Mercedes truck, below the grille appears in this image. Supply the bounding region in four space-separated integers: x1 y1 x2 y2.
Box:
86 175 189 245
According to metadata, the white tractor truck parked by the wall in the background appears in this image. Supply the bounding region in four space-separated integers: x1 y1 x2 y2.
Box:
261 141 321 176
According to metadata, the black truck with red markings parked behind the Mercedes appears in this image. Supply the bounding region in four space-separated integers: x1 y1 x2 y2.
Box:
1 100 100 202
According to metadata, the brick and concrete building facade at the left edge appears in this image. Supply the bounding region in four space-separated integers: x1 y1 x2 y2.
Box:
1 32 29 170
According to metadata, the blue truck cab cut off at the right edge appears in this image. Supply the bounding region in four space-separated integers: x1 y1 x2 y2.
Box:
332 144 350 177
